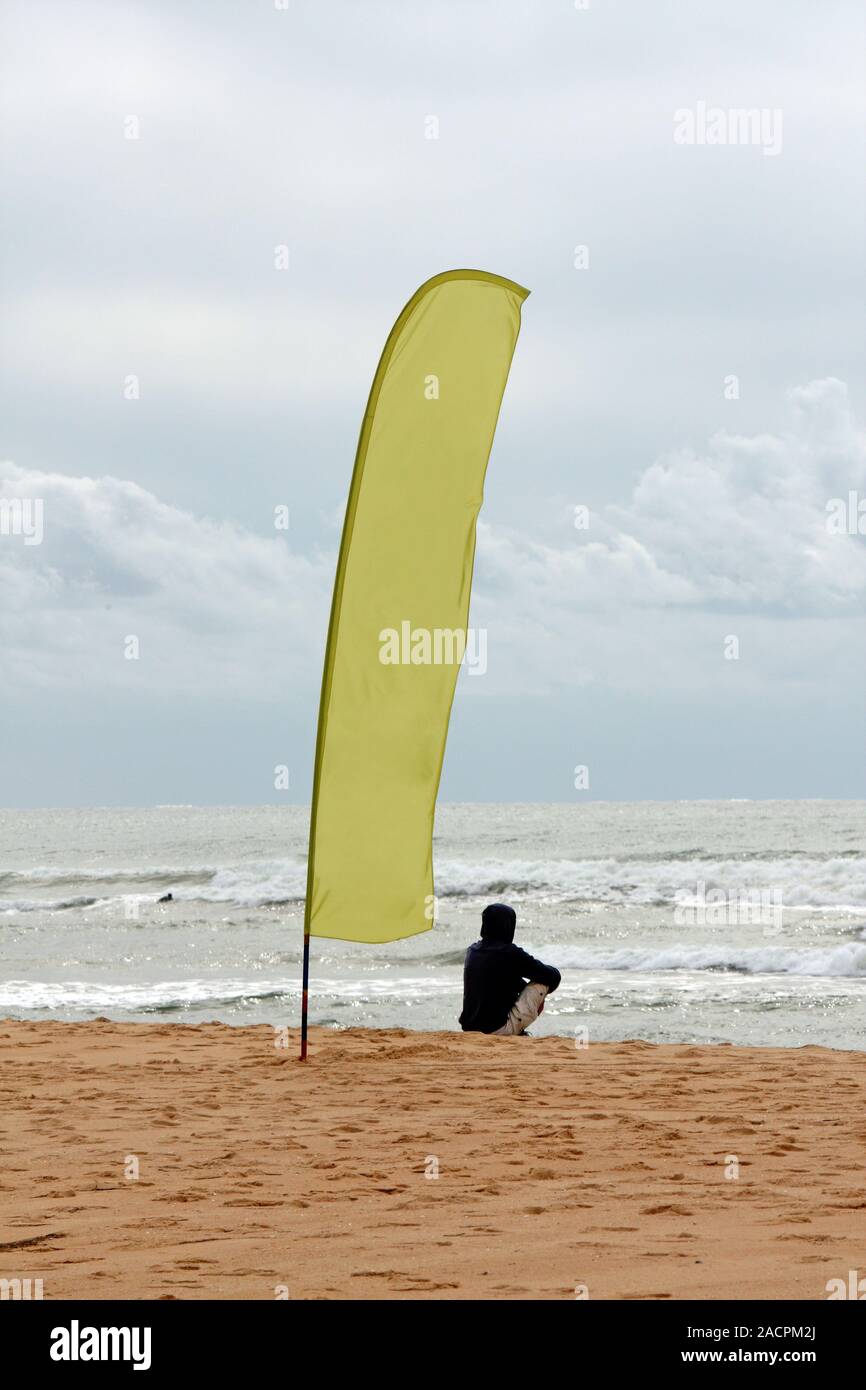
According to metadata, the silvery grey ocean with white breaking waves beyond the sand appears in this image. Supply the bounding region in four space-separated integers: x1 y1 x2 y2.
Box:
0 801 866 1049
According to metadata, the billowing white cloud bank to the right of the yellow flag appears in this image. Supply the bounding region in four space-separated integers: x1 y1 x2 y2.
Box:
464 378 866 695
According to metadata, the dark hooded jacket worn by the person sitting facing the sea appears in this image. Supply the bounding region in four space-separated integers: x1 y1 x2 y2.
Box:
460 902 562 1033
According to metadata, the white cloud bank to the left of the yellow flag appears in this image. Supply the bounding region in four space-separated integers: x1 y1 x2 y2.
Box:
0 464 332 698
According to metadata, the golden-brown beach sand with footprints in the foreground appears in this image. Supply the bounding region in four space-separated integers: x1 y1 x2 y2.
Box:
0 1022 866 1298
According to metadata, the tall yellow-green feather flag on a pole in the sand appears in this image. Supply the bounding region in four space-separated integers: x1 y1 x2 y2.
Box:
304 270 528 978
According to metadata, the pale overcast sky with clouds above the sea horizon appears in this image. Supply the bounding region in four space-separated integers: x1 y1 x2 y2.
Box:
0 0 866 806
